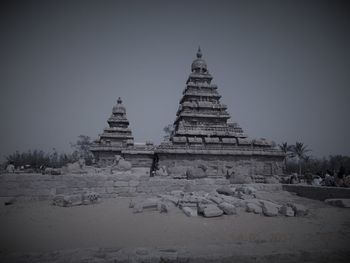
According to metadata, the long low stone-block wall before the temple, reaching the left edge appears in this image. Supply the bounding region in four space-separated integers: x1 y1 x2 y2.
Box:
0 173 229 200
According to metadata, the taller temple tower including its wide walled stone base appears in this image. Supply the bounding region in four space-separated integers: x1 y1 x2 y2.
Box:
155 48 284 181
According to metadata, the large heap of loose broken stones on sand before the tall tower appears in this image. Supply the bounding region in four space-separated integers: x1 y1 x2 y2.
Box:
129 186 308 217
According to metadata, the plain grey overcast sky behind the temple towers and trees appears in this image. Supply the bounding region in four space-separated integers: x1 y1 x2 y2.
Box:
0 0 350 160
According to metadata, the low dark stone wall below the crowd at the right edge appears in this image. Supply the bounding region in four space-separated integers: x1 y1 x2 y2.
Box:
283 184 350 201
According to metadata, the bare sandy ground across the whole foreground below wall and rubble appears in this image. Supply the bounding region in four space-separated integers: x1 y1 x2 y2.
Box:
0 191 350 262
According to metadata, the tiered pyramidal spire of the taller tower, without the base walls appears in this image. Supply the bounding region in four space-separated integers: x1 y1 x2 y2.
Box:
170 47 249 145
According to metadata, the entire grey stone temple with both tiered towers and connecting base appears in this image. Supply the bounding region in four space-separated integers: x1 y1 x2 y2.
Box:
92 48 284 182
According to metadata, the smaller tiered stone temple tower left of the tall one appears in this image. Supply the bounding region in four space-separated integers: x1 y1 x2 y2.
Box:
91 97 134 165
